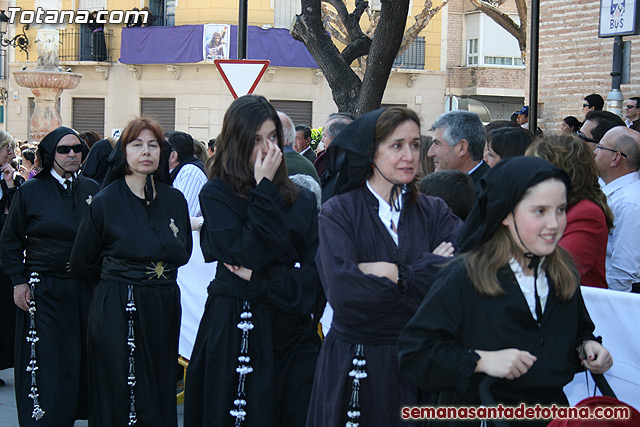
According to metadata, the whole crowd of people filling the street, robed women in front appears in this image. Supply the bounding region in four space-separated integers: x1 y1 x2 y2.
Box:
0 95 640 427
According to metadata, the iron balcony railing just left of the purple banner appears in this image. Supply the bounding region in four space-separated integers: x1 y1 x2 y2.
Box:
59 25 113 62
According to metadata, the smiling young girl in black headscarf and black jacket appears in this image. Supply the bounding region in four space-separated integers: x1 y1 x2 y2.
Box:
398 157 613 425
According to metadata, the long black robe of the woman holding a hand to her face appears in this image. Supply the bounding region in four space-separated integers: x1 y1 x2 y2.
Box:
184 179 320 427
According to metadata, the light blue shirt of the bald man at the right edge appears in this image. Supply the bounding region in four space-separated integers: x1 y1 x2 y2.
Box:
602 172 640 292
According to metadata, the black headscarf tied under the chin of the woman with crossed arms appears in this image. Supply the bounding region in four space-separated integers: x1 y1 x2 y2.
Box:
327 108 406 210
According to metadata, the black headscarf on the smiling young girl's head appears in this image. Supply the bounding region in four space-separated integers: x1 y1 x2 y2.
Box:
457 156 571 253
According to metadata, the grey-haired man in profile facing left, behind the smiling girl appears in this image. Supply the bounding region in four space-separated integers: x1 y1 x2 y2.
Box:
428 110 490 196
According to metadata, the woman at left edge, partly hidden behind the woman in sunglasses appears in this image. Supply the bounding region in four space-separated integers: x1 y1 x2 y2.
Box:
0 130 24 386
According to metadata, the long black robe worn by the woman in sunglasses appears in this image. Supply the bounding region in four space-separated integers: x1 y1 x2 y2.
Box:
0 171 99 426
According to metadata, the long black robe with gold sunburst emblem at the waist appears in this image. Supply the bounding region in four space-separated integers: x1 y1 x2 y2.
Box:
71 178 192 427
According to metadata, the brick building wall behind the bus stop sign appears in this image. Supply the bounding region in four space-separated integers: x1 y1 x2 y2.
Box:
540 0 640 131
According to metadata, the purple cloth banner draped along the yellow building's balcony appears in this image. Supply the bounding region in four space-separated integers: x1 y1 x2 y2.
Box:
119 25 318 68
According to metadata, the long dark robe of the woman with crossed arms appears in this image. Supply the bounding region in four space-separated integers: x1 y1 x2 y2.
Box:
306 186 462 427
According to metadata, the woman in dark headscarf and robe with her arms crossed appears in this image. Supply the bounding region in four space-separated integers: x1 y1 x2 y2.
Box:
306 107 462 427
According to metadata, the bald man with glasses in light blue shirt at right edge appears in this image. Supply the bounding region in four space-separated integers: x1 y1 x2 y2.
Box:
594 126 640 292
